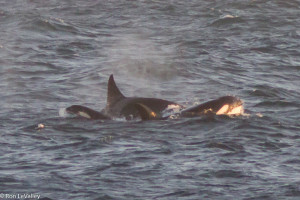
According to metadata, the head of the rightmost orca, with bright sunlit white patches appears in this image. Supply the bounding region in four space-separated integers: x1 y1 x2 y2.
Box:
216 96 244 115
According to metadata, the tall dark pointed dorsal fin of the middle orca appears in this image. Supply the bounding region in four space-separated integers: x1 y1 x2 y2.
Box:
106 74 125 108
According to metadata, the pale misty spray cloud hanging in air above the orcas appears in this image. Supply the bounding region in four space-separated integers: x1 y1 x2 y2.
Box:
102 34 177 95
